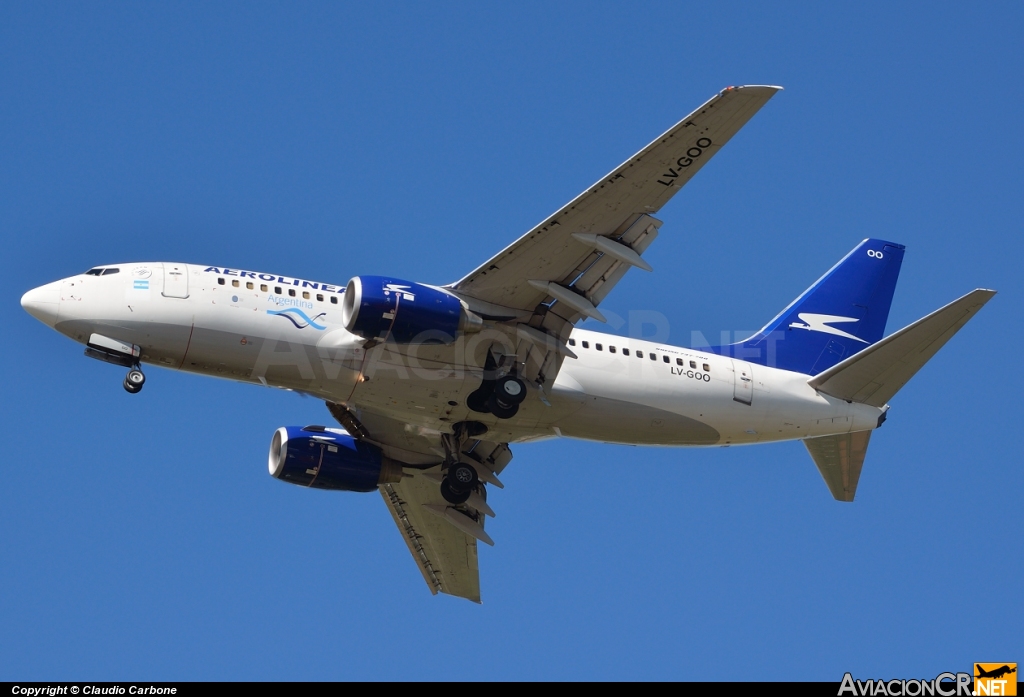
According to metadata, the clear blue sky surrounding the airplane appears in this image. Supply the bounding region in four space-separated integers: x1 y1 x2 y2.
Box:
0 2 1024 681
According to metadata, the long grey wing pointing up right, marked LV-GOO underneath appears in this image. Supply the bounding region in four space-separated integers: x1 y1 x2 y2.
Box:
447 85 781 317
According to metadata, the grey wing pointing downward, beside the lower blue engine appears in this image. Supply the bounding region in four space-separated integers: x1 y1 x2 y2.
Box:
380 475 483 603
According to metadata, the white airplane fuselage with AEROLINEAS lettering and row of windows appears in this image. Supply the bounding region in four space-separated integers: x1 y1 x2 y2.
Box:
23 263 884 445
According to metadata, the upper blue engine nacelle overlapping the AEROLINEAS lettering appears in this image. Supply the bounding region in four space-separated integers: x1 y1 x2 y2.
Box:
341 276 483 344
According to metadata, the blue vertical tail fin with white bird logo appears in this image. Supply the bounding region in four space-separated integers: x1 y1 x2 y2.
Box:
712 239 905 375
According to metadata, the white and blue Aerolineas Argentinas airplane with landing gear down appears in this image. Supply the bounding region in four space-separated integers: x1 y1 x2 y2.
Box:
22 85 995 603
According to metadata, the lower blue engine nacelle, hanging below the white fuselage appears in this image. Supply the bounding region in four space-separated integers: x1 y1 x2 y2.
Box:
268 426 401 491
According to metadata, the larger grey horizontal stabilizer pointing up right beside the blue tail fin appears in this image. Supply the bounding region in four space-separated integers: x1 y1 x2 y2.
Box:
804 289 995 407
